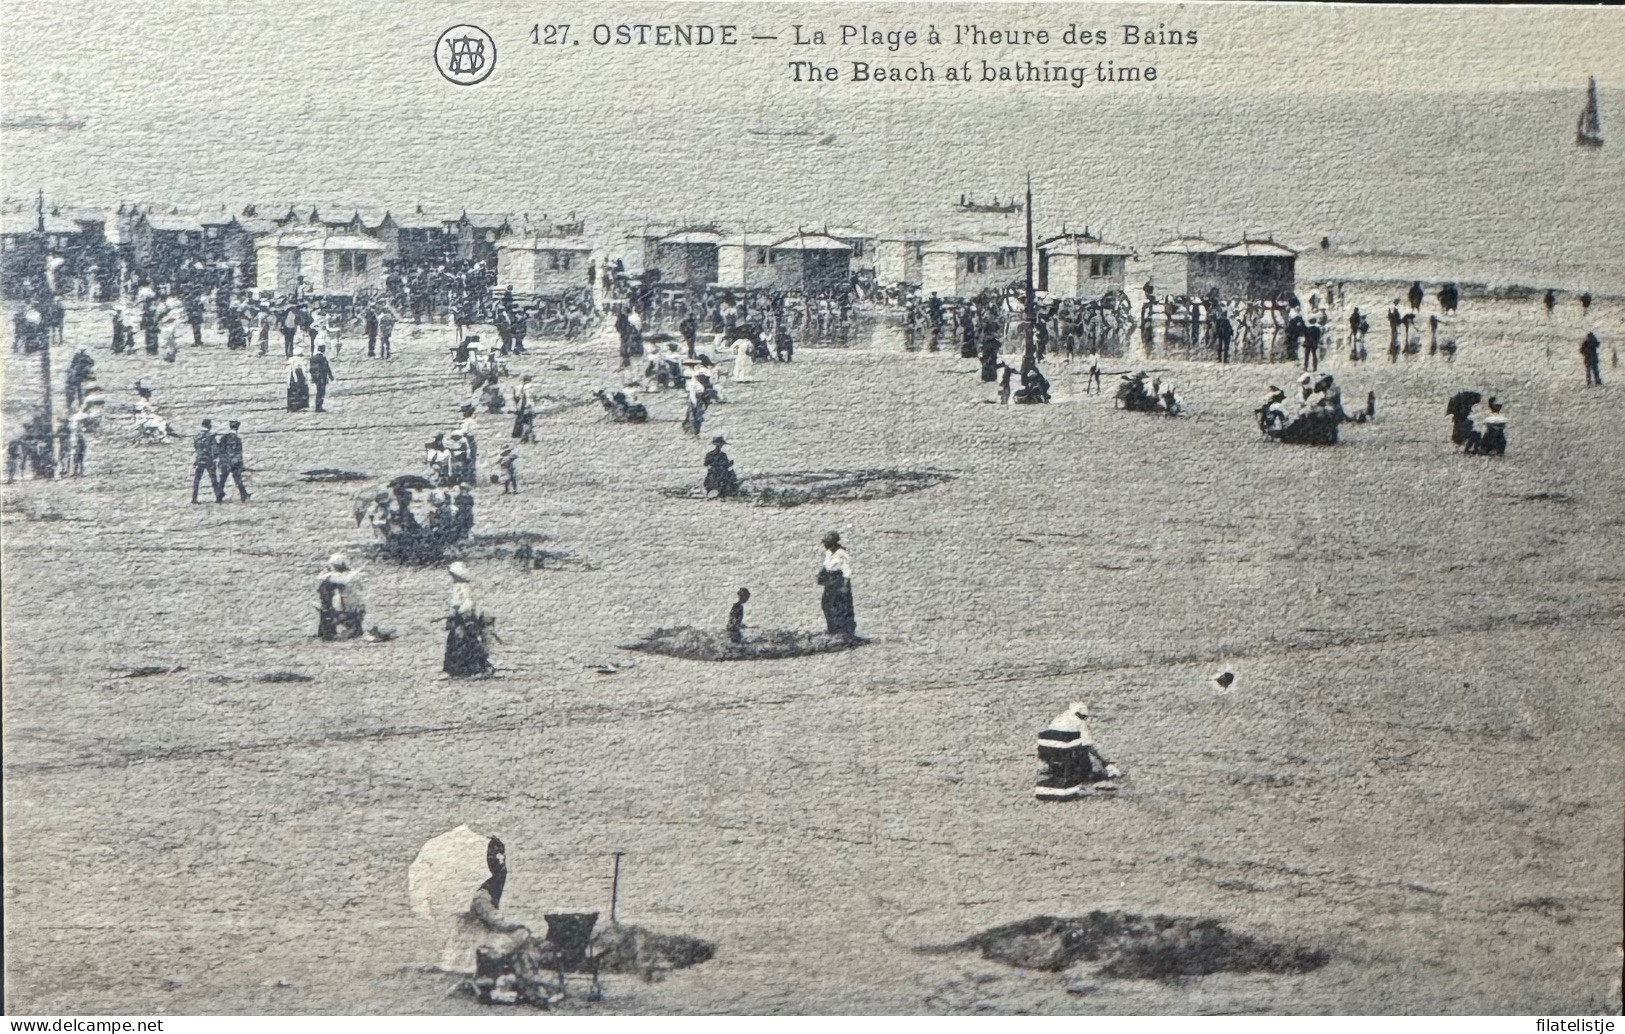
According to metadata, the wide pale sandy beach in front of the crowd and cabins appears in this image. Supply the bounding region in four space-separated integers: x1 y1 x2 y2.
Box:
0 291 1625 1013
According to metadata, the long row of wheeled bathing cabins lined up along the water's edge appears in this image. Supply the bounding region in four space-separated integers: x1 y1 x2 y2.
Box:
0 200 1297 299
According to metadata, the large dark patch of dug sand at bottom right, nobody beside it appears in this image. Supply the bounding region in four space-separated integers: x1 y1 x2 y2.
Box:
920 912 1329 980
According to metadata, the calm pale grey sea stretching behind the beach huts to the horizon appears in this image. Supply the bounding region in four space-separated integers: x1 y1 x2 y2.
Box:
0 85 1625 294
